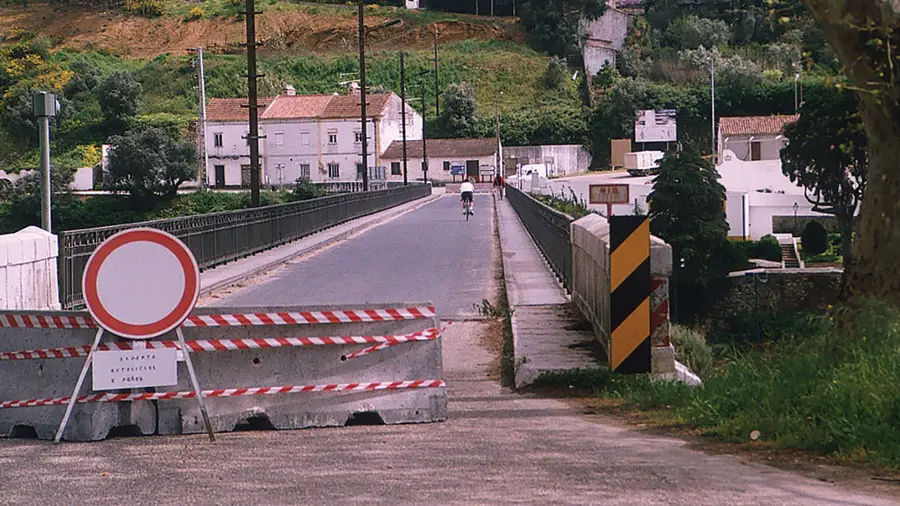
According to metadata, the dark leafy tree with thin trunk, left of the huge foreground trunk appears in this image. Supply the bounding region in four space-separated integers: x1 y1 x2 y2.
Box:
781 85 869 267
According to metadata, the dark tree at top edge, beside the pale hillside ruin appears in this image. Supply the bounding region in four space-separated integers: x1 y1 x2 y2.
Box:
522 0 606 58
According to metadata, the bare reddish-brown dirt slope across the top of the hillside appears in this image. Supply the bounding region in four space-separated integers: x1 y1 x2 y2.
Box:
0 4 522 58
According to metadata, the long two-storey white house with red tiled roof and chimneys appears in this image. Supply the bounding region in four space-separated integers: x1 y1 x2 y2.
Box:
206 86 422 188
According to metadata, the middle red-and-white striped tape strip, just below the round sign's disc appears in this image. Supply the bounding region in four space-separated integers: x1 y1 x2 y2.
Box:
0 328 440 361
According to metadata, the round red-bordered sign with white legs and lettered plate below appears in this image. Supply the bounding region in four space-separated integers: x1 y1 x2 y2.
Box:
55 228 215 443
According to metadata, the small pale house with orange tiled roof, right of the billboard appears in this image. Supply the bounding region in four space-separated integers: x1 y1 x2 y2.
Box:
718 115 799 163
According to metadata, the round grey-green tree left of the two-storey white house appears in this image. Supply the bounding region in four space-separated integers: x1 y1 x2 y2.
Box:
106 127 197 201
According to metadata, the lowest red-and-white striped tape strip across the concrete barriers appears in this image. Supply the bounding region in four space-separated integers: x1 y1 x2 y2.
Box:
0 380 446 409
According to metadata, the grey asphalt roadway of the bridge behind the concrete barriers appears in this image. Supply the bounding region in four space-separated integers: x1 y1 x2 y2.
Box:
216 195 494 318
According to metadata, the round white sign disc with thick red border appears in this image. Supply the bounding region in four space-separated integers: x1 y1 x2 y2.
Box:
82 228 200 339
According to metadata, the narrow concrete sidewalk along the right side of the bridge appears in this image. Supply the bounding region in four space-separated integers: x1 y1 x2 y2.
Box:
495 197 597 388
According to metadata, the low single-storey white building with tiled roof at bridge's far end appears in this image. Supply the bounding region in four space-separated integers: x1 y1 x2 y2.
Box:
382 137 502 182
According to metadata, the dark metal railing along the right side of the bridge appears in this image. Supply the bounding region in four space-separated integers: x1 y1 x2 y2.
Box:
506 185 575 291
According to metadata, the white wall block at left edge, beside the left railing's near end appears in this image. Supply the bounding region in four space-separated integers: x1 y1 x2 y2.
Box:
0 227 60 310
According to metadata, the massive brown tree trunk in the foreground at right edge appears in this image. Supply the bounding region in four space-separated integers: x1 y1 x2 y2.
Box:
806 0 900 306
